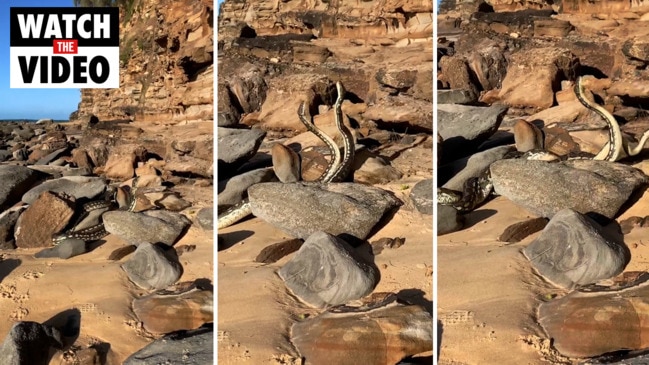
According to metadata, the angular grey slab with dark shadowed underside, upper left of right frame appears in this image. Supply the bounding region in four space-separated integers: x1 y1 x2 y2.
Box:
437 104 507 163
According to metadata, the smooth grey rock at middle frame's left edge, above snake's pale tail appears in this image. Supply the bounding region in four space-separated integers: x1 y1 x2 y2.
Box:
217 167 277 207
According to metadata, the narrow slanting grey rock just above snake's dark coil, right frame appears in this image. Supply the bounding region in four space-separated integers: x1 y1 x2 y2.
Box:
438 146 515 191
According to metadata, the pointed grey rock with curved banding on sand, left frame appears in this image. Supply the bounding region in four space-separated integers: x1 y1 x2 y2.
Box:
120 242 183 290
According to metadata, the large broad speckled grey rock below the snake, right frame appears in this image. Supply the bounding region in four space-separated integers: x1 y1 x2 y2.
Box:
490 159 649 218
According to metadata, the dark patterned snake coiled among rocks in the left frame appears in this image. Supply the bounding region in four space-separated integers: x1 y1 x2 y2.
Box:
52 177 139 245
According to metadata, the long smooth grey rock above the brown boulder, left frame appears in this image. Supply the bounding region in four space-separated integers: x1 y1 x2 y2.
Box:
22 176 106 204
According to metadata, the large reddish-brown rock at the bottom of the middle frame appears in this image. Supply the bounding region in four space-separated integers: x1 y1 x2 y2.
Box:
291 305 433 365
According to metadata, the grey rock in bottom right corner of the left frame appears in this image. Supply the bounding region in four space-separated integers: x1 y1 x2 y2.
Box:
124 326 214 365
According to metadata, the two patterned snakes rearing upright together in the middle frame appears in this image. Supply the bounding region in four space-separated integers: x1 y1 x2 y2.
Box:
218 81 355 229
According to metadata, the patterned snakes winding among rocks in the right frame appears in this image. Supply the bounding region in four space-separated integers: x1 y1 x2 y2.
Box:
437 77 636 212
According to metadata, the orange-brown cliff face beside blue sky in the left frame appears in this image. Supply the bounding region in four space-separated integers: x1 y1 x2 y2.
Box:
71 0 214 123
